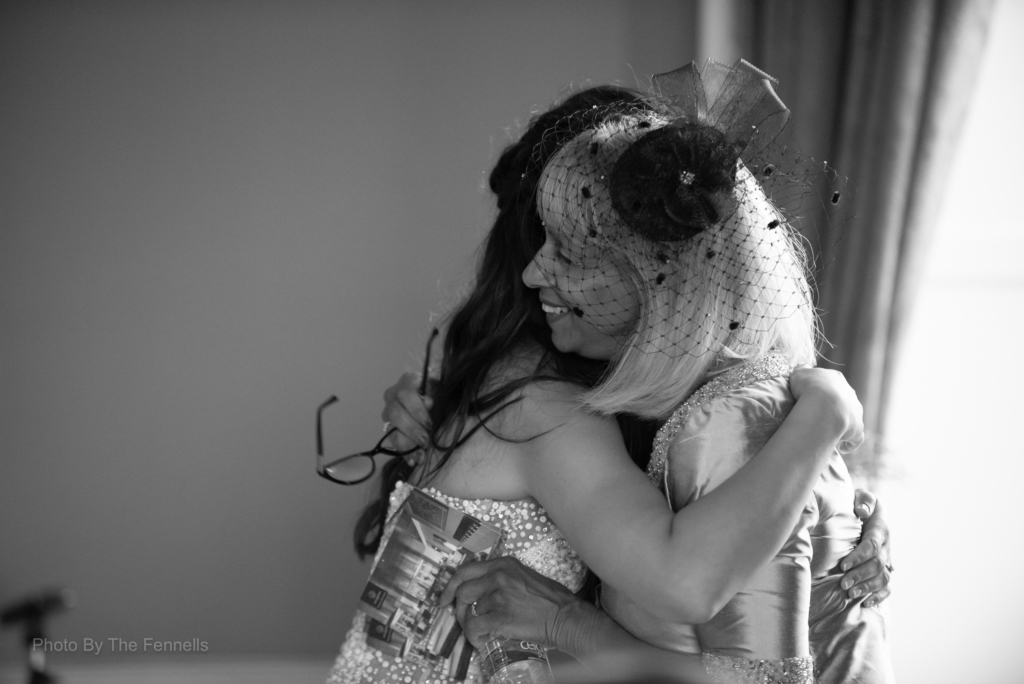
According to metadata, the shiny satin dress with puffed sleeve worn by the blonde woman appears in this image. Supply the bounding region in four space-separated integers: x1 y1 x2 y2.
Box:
602 355 893 684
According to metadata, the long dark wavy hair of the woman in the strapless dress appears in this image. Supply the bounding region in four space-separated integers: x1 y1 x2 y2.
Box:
355 86 653 558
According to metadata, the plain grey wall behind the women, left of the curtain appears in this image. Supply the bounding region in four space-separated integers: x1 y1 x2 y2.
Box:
0 0 694 659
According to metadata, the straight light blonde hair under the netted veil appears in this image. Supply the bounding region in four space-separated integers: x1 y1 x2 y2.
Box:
538 115 818 419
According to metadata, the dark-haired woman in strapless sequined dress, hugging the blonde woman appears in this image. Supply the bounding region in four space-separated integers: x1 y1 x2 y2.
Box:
330 70 888 682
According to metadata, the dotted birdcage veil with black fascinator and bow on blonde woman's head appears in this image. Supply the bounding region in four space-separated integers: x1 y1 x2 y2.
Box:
535 61 841 366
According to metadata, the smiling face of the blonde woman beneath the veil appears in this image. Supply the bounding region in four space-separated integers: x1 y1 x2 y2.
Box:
522 126 640 359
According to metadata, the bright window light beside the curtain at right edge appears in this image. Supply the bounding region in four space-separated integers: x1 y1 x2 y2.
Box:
881 0 1024 684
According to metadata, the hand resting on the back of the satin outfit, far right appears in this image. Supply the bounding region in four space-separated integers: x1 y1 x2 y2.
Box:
840 489 893 607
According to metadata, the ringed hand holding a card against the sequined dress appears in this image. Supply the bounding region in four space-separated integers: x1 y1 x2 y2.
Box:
440 556 598 652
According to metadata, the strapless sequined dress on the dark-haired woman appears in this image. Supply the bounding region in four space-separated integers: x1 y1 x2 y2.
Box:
327 482 587 684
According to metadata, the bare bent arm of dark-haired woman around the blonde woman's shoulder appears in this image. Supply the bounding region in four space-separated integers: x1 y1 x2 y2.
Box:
485 374 860 624
